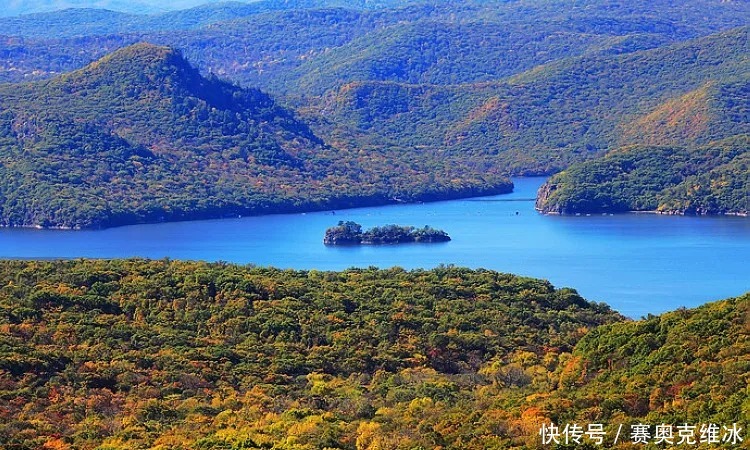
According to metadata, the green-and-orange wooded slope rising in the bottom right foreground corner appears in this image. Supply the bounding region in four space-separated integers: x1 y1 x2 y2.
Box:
526 293 750 442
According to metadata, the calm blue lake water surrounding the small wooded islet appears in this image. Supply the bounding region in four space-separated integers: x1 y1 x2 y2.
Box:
0 178 750 318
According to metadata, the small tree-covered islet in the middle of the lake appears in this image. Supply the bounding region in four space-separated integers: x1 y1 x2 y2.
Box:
323 221 451 245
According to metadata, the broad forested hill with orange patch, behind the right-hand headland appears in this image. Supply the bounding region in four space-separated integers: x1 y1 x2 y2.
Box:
311 27 750 174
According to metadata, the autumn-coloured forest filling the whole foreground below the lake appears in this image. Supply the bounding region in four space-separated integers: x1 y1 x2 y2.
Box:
0 260 750 450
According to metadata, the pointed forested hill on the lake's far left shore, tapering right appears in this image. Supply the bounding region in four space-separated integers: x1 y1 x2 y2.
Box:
0 44 511 228
